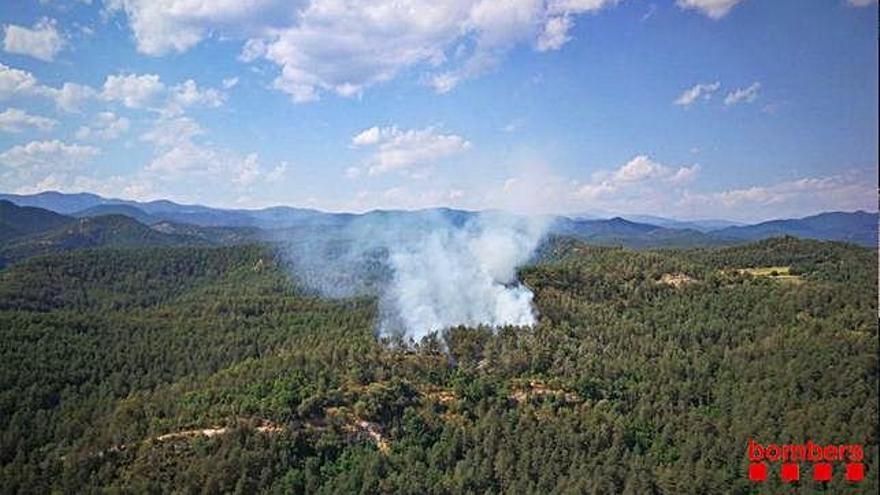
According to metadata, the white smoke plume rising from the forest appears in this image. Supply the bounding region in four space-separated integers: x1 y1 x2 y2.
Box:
278 210 547 340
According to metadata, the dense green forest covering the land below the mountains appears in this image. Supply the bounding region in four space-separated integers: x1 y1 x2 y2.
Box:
0 237 880 494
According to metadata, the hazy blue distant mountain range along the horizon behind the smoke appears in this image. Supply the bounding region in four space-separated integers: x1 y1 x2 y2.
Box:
0 192 878 266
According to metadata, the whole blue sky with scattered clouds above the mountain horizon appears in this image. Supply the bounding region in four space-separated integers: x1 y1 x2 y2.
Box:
0 0 878 220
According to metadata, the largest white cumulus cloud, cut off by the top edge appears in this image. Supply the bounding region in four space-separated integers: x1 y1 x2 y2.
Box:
109 0 618 102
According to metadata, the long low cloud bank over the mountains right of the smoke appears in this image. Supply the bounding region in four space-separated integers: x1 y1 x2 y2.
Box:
488 155 877 221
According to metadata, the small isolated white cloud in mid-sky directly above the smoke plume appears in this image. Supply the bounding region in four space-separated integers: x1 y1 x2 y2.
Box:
352 126 471 175
